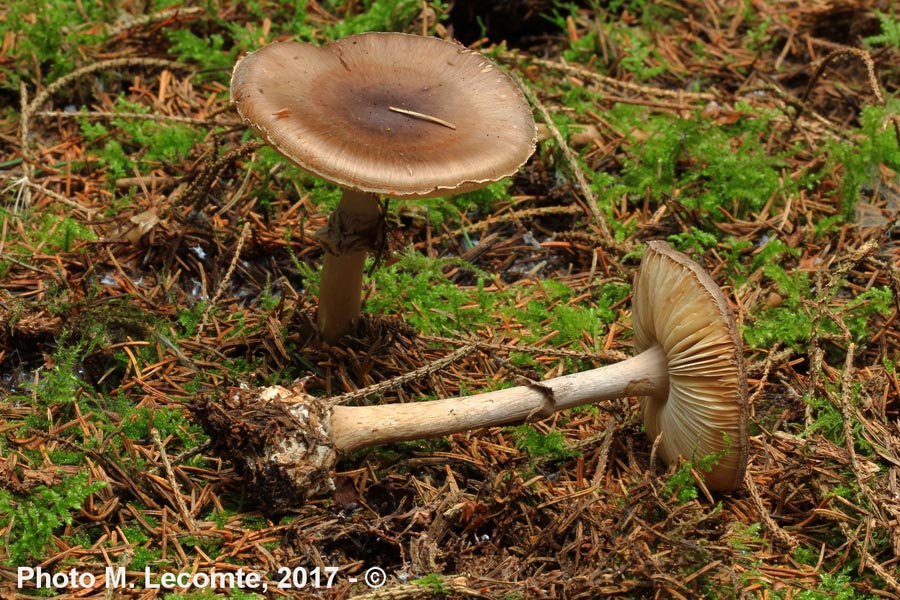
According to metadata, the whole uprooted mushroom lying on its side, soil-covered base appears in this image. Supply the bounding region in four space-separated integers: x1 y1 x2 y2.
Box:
201 241 748 502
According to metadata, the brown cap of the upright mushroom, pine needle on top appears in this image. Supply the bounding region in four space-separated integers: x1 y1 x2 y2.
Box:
231 33 537 198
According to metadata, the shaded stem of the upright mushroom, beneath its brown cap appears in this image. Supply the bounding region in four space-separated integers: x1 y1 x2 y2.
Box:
316 190 380 344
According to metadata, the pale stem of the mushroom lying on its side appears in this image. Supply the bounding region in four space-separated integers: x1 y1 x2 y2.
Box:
329 345 669 452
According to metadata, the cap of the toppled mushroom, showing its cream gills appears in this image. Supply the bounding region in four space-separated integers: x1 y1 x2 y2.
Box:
633 241 749 491
